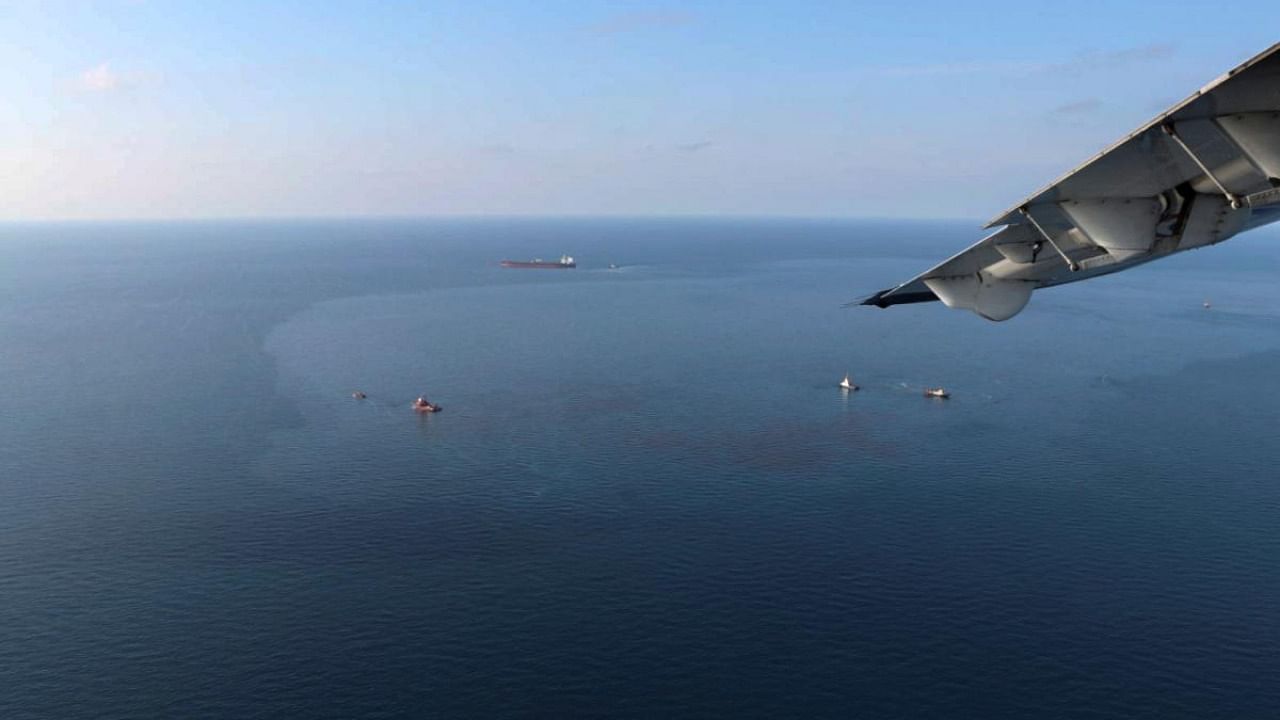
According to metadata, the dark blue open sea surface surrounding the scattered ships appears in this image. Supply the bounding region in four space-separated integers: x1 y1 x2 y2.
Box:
0 215 1280 719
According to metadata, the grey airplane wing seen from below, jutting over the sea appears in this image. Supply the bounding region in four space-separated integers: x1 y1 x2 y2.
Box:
851 44 1280 320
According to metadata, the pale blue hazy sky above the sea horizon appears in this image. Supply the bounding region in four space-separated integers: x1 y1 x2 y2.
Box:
0 0 1277 219
